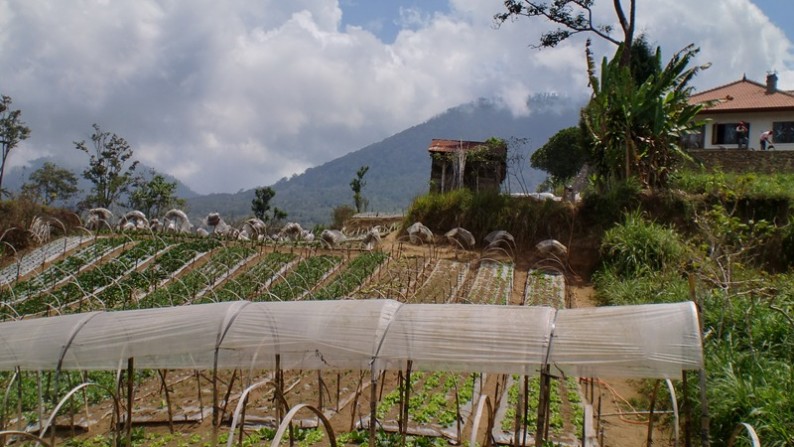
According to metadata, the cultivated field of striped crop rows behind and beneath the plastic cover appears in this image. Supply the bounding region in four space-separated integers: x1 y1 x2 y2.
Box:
0 235 583 447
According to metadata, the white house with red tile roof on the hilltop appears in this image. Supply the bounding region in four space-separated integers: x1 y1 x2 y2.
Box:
687 73 794 150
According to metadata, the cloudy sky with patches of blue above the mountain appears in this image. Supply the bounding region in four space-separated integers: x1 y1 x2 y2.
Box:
0 0 794 194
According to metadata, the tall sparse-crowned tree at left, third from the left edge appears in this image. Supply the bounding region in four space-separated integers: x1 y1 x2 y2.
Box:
74 124 138 208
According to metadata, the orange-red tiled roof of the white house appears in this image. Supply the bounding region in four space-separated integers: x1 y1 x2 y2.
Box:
689 78 794 113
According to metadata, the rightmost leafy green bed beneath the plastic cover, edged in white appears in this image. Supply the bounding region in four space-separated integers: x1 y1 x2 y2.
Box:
492 376 584 445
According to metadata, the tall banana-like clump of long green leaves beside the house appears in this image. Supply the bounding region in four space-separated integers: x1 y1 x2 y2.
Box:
582 42 707 191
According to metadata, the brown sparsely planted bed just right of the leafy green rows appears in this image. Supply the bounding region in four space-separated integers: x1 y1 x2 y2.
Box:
352 256 431 302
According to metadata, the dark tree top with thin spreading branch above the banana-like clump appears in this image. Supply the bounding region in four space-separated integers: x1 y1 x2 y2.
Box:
494 0 637 66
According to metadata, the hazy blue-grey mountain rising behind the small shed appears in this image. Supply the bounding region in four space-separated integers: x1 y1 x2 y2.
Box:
187 94 582 228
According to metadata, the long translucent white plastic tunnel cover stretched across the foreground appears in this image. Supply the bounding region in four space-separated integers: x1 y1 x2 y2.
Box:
0 300 703 378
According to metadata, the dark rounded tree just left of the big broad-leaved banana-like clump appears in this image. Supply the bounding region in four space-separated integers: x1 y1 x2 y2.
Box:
529 126 587 184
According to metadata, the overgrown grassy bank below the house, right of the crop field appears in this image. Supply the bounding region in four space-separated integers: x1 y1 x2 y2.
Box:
406 172 794 445
